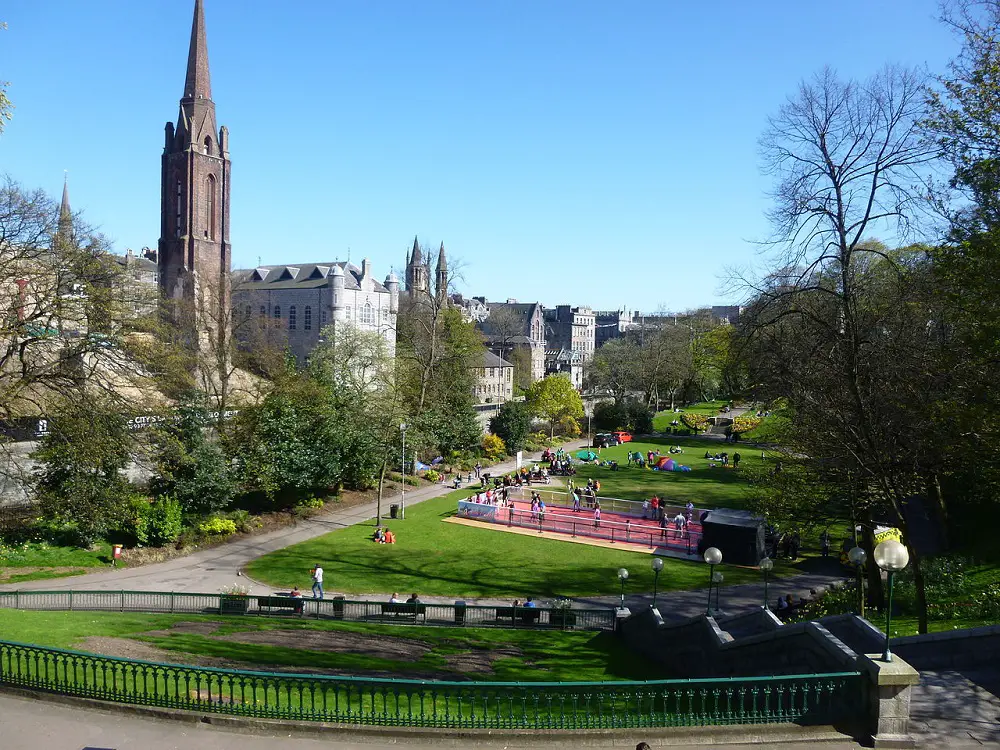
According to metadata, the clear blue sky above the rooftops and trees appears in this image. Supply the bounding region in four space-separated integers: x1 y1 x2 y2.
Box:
0 0 957 311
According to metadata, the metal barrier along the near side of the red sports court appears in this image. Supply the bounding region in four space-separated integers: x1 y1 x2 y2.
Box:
458 500 701 555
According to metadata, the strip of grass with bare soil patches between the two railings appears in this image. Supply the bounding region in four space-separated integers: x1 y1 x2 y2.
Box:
0 610 662 682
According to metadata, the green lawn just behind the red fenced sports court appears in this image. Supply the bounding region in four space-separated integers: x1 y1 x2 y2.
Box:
577 437 761 508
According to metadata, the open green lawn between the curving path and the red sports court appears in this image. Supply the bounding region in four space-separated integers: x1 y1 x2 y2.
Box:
247 490 759 599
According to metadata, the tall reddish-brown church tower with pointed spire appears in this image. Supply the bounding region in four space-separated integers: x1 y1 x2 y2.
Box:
159 0 231 344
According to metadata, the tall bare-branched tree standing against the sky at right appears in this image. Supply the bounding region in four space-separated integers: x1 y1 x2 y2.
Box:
748 67 937 627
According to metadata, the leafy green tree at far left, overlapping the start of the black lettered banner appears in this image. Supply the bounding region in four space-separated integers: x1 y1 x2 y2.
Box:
32 394 134 546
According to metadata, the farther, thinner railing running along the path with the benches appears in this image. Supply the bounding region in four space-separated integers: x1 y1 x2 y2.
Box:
0 591 615 630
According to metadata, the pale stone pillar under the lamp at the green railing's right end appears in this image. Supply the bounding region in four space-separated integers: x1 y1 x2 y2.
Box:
859 654 920 748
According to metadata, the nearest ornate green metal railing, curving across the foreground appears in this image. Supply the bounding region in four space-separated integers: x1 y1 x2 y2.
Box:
0 641 866 729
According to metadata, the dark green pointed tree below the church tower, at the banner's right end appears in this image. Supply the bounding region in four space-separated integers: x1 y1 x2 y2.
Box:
150 391 236 514
